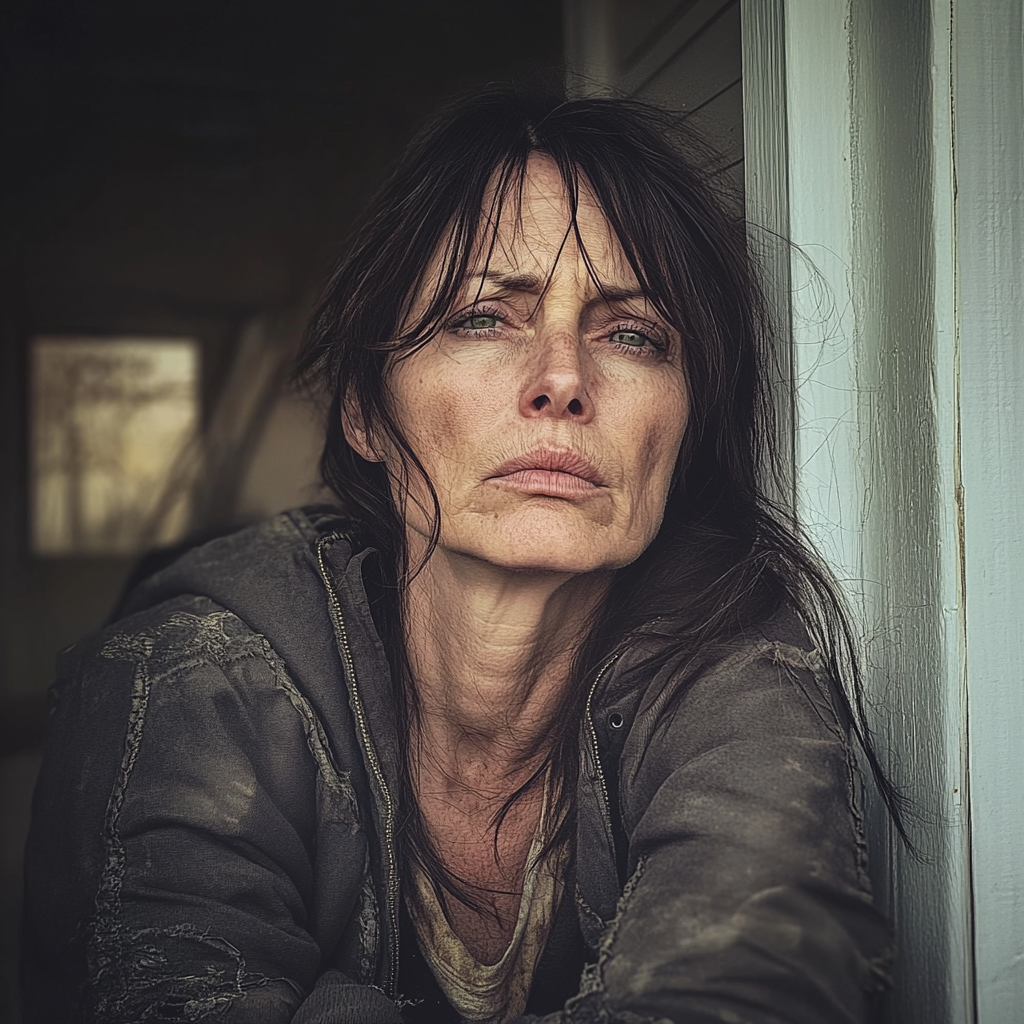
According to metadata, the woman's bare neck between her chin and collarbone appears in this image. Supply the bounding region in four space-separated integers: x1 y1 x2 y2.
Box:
403 549 611 797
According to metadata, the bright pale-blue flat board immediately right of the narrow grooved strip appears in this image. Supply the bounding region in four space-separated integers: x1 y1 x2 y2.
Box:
778 0 865 577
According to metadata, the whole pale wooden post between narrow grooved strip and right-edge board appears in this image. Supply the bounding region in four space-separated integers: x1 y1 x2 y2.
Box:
778 0 970 1024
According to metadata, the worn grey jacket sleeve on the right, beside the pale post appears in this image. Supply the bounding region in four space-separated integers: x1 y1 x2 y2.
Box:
524 641 889 1024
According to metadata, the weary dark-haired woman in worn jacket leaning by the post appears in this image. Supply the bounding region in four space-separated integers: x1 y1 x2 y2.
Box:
26 91 892 1024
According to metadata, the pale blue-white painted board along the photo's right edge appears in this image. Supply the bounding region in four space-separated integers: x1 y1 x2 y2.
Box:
953 0 1024 1024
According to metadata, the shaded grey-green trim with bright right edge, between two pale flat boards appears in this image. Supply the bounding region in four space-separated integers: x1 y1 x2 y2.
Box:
850 0 973 1024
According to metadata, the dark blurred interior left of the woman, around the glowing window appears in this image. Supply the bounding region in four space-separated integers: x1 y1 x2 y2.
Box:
0 0 562 1020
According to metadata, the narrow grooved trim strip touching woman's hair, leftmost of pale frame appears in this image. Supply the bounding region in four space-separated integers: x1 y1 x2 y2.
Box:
739 0 796 508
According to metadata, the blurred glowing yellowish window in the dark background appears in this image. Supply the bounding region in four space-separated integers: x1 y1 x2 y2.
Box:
31 337 199 555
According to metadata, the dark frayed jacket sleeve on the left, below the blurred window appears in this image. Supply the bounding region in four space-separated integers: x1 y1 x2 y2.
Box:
24 599 399 1024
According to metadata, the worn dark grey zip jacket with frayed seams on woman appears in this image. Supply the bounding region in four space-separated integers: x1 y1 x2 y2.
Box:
24 510 888 1024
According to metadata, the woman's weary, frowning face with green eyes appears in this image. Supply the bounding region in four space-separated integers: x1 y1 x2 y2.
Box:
348 156 689 573
